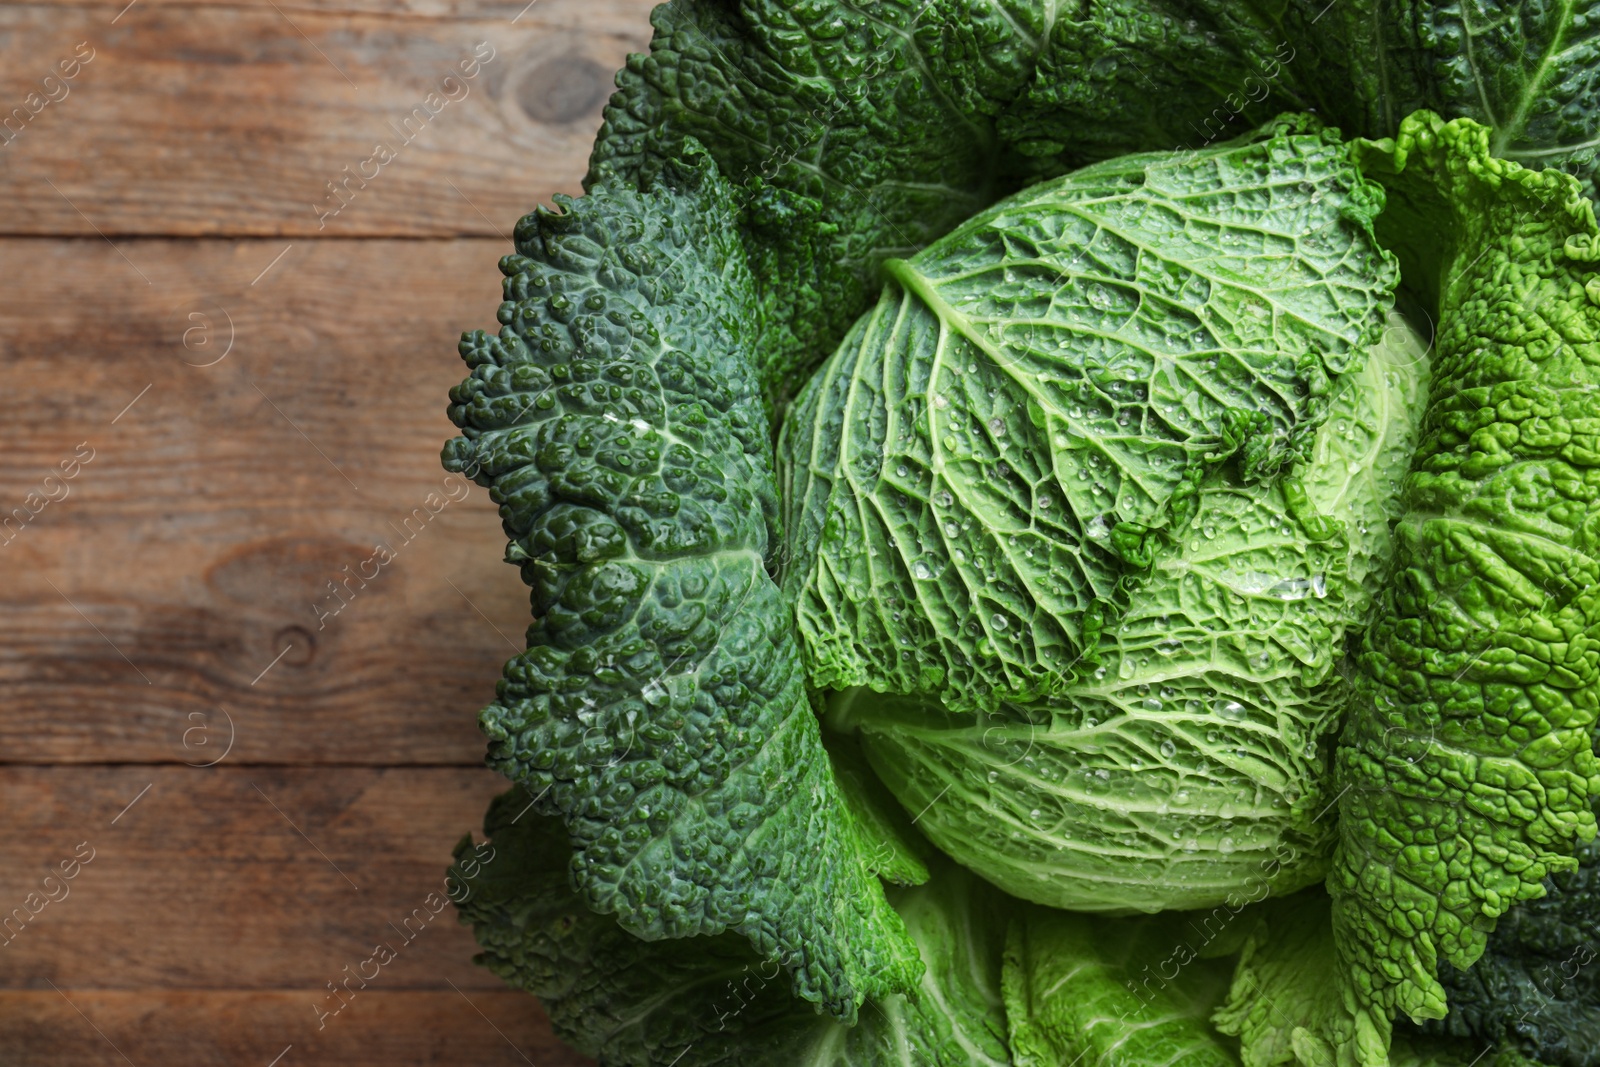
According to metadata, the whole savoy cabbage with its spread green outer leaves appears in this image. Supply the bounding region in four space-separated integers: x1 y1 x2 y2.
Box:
443 0 1600 1067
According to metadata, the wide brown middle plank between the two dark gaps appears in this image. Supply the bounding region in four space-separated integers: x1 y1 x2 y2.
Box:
0 238 530 766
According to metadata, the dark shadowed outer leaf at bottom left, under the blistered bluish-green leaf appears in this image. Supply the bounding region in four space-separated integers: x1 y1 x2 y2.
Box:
451 789 1011 1067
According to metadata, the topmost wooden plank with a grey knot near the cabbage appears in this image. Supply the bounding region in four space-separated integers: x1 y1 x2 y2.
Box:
0 0 651 237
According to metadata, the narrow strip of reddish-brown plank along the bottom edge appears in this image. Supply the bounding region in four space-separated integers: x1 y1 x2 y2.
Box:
0 989 590 1067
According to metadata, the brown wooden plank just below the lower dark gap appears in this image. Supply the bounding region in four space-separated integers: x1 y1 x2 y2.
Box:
0 765 537 991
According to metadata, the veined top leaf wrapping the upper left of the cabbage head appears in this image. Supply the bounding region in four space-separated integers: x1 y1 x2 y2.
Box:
779 123 1397 712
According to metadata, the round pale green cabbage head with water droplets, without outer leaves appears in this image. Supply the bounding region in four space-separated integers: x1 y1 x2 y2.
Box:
779 126 1426 912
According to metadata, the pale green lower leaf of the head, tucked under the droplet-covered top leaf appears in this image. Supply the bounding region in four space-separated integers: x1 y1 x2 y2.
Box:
832 308 1427 912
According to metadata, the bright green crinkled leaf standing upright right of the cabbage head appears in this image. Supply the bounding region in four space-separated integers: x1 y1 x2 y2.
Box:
1328 114 1600 1064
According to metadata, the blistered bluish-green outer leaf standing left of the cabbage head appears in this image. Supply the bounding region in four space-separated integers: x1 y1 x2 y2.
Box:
445 146 920 1021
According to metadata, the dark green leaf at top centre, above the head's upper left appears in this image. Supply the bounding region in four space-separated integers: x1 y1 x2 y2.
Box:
587 0 1053 406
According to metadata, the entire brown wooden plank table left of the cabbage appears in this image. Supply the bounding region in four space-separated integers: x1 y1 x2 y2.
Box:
0 0 651 1067
